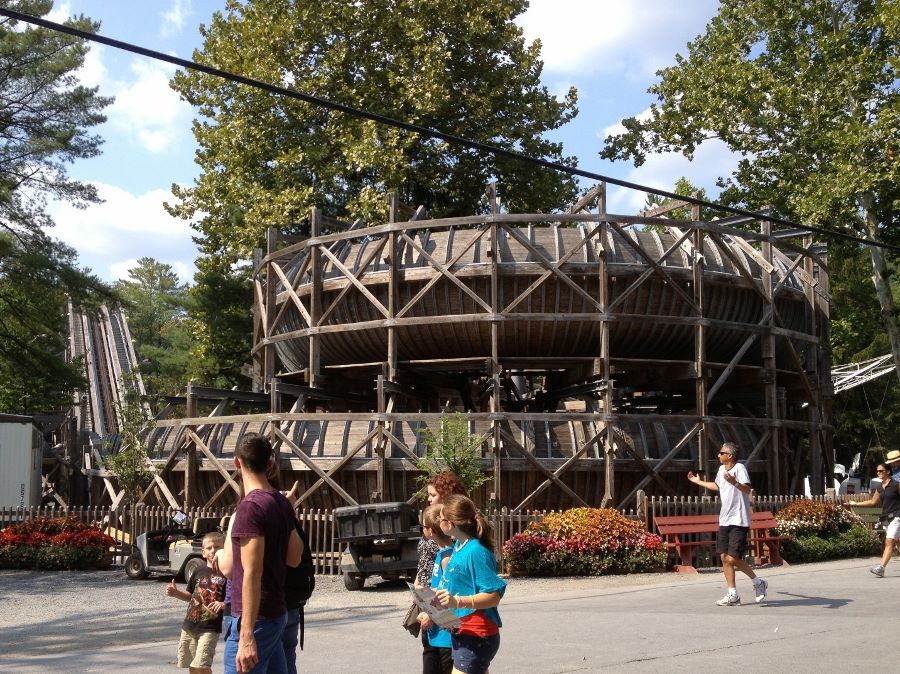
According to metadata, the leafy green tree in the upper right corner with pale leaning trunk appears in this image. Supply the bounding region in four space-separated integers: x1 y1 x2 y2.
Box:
601 0 900 374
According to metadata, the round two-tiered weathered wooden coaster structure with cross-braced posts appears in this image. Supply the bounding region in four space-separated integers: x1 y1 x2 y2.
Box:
145 184 833 509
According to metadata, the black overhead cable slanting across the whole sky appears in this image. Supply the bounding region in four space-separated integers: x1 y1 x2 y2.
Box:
0 7 900 252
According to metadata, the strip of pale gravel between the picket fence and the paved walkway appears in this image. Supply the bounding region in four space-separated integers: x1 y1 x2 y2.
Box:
0 568 698 656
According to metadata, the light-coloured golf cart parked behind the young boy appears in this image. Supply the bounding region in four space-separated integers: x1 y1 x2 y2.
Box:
125 510 219 582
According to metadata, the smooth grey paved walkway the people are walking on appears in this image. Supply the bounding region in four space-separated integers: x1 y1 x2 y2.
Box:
0 559 900 674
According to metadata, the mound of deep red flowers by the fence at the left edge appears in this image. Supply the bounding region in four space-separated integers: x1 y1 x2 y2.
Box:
0 517 116 570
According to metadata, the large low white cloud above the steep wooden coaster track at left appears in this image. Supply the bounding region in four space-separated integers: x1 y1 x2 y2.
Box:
48 183 197 282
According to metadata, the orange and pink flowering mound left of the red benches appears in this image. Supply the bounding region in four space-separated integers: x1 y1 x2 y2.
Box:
503 508 666 576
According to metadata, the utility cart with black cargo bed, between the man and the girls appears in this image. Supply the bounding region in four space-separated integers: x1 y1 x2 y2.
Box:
334 501 422 590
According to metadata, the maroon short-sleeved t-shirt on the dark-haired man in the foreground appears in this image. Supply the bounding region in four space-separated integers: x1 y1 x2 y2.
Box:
231 489 295 618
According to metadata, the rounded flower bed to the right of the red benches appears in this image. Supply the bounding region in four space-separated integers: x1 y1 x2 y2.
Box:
775 499 881 564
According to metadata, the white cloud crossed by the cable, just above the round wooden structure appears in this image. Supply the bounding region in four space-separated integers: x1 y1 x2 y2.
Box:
608 140 738 215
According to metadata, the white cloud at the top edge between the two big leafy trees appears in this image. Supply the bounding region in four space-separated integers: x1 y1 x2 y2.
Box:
518 0 718 80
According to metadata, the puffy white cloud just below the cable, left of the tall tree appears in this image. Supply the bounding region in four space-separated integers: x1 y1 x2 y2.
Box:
108 61 192 154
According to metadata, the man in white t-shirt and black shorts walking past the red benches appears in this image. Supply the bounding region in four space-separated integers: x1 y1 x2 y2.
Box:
688 442 769 606
